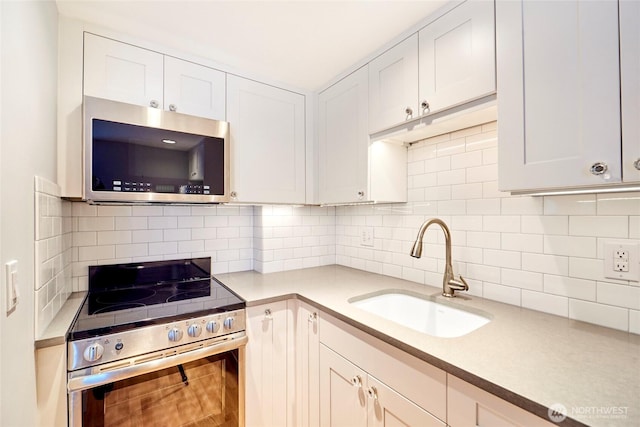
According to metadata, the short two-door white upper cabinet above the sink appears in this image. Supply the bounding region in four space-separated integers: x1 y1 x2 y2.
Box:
369 0 496 133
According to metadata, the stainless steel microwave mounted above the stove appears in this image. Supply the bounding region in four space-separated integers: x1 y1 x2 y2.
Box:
83 96 230 204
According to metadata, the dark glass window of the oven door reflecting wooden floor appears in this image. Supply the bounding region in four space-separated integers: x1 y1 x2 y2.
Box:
82 351 238 427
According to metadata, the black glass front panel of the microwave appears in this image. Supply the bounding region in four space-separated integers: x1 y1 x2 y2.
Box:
91 118 225 195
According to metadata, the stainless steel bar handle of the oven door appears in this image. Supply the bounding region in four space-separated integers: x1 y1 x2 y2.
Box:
67 335 249 393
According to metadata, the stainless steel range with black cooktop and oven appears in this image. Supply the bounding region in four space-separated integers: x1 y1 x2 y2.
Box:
67 258 247 427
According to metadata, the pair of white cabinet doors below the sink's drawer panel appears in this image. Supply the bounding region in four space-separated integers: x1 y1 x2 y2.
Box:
320 345 445 427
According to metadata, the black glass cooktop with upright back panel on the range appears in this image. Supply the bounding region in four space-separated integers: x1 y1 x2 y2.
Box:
68 258 245 340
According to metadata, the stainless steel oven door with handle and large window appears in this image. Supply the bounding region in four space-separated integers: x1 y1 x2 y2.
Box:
67 336 247 427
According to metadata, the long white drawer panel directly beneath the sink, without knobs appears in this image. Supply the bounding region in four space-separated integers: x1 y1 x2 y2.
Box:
320 316 447 420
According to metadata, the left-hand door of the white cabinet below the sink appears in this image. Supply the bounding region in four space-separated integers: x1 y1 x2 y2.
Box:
320 345 367 427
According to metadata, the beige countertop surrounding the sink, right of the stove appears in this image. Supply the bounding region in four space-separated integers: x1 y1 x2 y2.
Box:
216 266 640 426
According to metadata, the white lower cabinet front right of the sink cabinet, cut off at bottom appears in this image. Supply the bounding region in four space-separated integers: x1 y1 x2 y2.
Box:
447 375 556 427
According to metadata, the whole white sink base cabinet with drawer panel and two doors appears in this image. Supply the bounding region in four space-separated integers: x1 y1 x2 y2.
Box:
320 315 447 427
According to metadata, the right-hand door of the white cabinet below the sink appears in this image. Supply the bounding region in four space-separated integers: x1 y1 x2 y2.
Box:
367 376 445 427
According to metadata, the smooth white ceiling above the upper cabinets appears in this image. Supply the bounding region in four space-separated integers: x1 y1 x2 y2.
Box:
56 0 446 91
